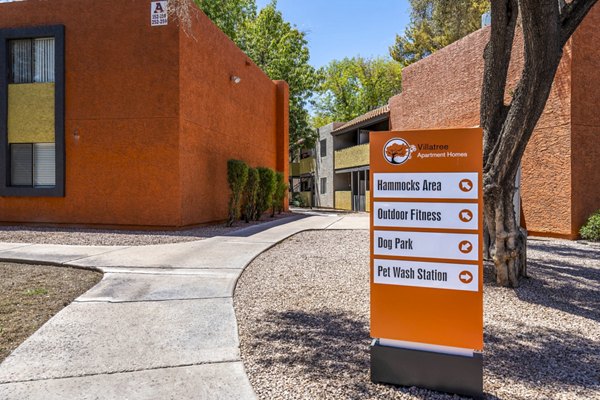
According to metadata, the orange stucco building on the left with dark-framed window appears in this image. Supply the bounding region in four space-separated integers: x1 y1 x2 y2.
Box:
0 0 288 227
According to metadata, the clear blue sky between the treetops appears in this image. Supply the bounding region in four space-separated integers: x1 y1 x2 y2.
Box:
256 0 410 67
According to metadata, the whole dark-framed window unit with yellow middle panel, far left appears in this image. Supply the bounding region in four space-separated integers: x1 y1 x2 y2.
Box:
0 26 65 197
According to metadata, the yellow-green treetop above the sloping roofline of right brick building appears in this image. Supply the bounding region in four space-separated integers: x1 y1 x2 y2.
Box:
390 0 490 67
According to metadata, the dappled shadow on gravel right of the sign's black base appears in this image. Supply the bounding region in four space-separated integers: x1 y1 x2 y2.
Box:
484 327 600 389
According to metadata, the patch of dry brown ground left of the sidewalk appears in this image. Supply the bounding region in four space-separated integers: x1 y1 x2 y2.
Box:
0 263 102 362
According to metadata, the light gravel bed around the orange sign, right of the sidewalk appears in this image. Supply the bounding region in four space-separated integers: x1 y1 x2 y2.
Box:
235 231 600 399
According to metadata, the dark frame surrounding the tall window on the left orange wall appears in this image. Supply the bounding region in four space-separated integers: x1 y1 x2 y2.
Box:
0 25 65 197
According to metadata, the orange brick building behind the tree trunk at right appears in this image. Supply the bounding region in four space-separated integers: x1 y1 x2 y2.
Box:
389 5 600 239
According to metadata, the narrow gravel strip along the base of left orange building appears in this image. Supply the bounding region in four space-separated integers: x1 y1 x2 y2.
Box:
0 213 294 246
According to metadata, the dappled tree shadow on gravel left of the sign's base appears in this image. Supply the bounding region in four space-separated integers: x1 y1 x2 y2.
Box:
254 311 490 400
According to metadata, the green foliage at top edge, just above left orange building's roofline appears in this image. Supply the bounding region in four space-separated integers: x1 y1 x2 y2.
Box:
194 0 256 47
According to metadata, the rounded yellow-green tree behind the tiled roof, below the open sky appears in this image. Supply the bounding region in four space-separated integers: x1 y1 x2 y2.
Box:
313 57 402 127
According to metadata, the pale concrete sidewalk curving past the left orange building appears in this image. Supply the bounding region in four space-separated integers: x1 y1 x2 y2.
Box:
0 214 368 400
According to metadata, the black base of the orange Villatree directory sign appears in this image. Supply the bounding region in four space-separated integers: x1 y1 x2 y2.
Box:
371 340 483 399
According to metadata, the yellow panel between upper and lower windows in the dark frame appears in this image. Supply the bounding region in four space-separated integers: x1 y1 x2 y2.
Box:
8 83 54 143
